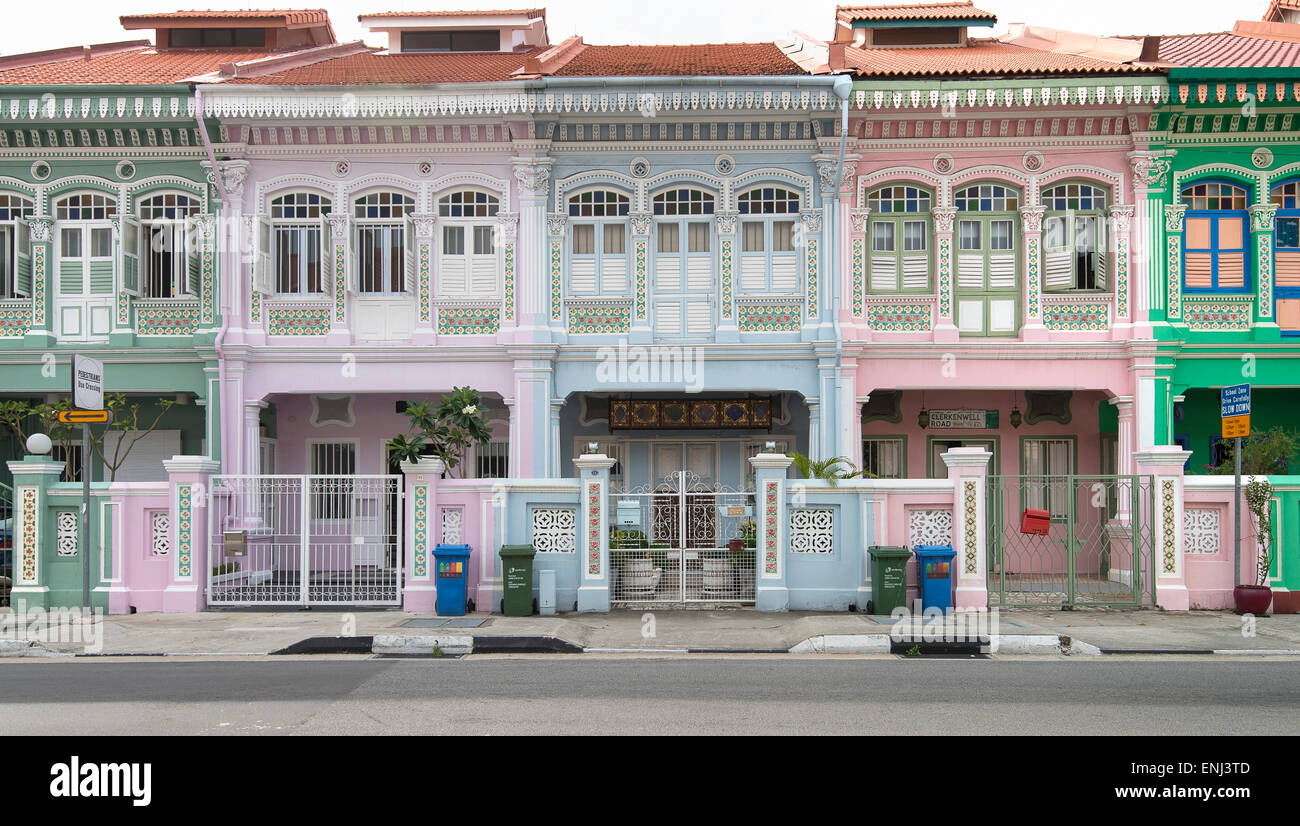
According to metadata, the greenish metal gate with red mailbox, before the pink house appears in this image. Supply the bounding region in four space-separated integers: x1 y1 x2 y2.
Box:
988 476 1156 607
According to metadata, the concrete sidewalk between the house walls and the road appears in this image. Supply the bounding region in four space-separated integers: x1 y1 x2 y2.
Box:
0 609 1300 656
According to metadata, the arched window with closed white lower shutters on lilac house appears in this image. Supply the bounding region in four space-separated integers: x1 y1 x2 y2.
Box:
437 190 501 298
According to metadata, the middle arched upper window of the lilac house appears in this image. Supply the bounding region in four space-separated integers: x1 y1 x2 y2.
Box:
352 191 415 295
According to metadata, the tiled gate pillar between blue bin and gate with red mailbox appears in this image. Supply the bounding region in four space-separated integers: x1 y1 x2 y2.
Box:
943 447 993 609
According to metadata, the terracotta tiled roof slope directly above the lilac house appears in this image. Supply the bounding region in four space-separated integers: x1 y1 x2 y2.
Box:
228 49 542 86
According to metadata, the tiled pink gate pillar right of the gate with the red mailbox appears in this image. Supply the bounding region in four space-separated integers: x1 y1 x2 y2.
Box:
1134 446 1192 611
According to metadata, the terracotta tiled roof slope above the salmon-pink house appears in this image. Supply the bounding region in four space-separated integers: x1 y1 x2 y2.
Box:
845 39 1154 77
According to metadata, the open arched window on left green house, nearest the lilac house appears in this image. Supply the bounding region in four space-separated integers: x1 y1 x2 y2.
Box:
137 193 200 298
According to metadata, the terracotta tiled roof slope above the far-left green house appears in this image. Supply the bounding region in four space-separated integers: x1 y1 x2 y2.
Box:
0 47 278 86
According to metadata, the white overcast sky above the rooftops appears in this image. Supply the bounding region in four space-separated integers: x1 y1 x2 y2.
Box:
0 0 1269 55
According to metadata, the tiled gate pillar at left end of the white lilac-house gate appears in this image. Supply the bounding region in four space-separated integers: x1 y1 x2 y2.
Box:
163 457 221 614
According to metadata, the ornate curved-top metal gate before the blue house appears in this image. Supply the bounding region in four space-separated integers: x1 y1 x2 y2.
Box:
610 471 757 605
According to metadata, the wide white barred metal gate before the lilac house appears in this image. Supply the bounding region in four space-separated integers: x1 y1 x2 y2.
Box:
208 476 404 605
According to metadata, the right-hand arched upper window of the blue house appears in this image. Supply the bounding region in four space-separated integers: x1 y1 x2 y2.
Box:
736 186 800 294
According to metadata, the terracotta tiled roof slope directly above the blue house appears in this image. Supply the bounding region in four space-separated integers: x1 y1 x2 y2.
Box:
555 43 803 77
